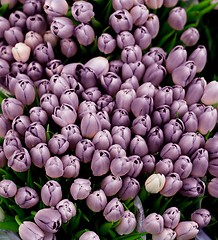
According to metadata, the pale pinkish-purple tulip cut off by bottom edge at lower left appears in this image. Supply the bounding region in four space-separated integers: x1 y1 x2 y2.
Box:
18 221 45 240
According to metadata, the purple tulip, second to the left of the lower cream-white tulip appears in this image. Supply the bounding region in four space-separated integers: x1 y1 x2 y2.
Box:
101 175 122 197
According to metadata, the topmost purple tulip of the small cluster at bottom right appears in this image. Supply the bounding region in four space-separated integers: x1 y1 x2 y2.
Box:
162 207 180 229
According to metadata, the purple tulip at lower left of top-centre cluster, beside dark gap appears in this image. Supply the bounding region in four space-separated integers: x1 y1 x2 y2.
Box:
98 33 116 54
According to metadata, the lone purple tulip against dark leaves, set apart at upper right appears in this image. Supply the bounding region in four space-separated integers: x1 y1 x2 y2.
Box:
180 27 200 47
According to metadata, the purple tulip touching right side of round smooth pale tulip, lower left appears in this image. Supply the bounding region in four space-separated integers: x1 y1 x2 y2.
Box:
61 154 80 178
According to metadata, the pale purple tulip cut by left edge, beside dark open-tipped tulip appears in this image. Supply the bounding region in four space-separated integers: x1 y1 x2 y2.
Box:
0 179 17 198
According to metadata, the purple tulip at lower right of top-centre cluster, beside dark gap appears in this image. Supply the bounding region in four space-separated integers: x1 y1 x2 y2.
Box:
133 26 152 50
